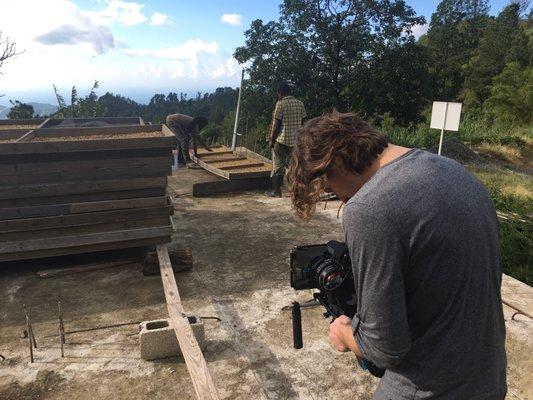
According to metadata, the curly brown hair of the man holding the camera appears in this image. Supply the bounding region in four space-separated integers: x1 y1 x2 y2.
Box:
287 112 389 220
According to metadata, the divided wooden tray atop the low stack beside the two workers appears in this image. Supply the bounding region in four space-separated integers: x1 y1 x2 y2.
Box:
192 146 272 180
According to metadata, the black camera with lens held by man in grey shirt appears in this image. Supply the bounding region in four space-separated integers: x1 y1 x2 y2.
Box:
290 240 385 378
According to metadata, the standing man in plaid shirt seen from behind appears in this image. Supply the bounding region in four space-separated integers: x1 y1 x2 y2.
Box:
267 83 306 197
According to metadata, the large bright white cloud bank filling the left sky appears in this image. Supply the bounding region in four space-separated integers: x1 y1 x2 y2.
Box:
0 0 238 97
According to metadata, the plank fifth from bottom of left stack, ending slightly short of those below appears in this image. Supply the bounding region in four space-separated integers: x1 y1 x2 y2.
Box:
0 196 167 219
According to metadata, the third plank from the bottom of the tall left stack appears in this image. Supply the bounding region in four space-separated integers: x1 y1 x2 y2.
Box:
0 215 170 243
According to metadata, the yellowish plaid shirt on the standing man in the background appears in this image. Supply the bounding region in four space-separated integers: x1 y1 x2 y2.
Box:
270 96 306 146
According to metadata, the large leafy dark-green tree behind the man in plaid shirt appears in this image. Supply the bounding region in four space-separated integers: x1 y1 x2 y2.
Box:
235 0 427 123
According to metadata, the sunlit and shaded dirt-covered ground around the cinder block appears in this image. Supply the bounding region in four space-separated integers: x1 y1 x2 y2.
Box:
0 170 533 400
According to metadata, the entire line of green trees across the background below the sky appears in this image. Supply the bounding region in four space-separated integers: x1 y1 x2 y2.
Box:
5 0 533 145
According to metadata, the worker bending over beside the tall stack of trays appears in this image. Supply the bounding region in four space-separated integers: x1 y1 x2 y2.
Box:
166 114 212 169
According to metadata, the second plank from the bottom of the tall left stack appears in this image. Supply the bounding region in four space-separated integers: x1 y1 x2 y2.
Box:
0 223 172 253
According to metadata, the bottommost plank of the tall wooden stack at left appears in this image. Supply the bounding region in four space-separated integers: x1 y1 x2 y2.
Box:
0 236 170 268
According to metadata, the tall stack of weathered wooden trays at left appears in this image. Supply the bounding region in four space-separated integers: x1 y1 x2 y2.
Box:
0 123 176 261
